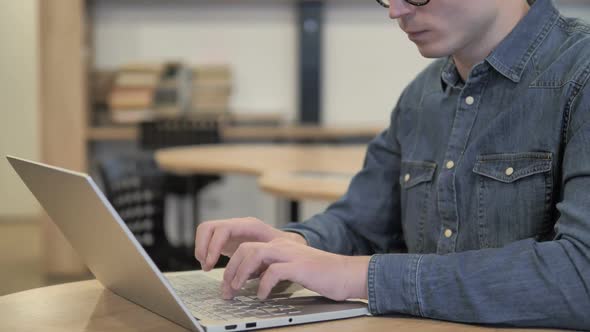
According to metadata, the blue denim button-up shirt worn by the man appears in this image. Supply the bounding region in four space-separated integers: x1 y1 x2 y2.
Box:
284 0 590 329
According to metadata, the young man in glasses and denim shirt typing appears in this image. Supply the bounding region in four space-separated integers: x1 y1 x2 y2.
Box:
195 0 590 329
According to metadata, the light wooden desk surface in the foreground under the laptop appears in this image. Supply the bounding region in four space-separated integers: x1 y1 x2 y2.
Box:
0 280 560 332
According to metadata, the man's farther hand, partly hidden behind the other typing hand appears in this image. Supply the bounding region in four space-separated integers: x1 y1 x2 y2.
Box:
195 218 307 271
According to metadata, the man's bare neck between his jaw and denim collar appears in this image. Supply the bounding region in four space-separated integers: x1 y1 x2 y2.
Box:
453 1 530 81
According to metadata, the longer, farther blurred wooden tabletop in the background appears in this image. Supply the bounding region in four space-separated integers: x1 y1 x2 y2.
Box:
156 144 366 175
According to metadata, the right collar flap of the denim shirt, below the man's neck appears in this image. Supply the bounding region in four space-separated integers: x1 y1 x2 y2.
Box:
486 0 559 83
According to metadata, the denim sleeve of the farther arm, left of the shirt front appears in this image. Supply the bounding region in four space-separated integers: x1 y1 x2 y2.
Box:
283 98 405 255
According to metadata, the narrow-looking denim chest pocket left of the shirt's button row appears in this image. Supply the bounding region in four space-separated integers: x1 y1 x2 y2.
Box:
399 160 436 253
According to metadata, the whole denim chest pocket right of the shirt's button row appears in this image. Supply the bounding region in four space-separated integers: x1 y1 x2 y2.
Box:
473 152 553 248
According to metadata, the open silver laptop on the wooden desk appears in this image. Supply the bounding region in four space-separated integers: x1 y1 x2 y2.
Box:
7 156 369 332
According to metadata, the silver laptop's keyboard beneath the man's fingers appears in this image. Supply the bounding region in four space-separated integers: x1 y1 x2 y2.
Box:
169 274 302 320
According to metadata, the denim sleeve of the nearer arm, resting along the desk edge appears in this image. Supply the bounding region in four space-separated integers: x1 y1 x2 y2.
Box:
368 103 590 330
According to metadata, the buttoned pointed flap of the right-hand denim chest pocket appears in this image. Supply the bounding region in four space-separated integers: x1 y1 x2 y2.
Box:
473 152 552 183
